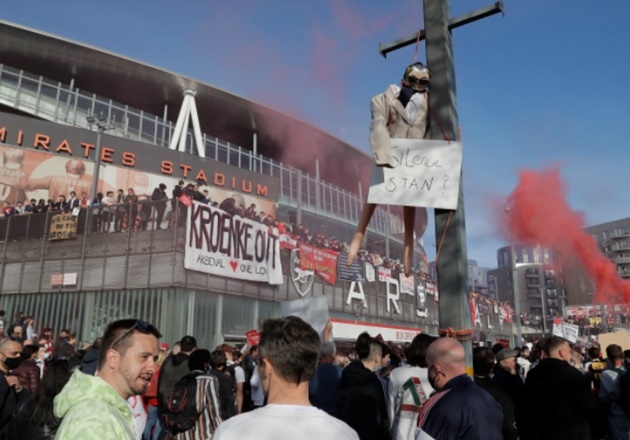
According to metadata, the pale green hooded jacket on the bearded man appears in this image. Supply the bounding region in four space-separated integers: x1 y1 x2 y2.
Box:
54 371 136 440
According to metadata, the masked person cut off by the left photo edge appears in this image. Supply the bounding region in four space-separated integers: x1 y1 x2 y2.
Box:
0 338 29 439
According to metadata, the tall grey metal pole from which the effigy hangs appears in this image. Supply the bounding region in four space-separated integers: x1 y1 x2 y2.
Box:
423 0 473 376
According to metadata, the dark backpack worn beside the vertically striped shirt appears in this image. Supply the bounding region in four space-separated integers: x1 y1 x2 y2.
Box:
164 371 203 434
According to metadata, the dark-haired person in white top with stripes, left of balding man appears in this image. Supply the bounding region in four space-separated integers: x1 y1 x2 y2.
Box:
387 333 436 440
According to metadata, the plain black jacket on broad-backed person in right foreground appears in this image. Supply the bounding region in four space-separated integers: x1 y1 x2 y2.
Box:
518 358 598 440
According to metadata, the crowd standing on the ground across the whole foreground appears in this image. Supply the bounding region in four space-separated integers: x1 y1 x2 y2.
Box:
0 311 630 440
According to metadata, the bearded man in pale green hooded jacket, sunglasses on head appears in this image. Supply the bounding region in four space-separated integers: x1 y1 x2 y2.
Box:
54 319 161 440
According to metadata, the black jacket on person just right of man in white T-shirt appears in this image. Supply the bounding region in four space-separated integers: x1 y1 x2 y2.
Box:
337 361 390 440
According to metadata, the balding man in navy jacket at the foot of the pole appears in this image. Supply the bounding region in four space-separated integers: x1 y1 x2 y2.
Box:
415 338 502 440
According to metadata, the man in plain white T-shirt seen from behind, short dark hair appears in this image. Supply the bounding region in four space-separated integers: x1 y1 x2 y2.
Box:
213 316 359 440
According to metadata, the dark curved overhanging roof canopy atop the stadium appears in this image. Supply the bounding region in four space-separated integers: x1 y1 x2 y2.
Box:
0 20 372 192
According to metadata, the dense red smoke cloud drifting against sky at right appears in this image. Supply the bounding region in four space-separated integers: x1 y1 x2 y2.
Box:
506 166 630 303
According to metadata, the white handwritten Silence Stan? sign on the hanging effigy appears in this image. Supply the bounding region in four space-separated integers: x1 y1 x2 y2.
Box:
368 139 462 209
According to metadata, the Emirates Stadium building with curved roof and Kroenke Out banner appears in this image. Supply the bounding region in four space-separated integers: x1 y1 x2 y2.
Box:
0 21 511 347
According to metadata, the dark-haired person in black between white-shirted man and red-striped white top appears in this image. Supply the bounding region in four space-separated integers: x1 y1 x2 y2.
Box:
337 333 390 440
